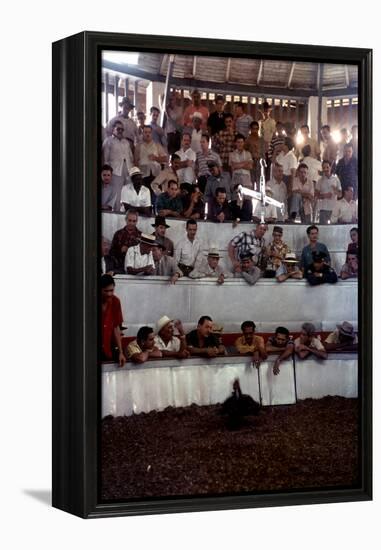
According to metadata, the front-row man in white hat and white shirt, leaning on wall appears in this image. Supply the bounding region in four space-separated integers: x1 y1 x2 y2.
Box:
155 315 190 359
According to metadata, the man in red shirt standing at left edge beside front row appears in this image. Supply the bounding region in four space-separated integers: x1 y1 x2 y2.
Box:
101 273 126 367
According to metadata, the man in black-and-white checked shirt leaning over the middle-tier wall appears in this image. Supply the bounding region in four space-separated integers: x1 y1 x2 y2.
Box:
228 223 268 272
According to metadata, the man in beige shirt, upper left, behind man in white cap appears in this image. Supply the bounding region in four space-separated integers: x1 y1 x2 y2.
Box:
135 125 168 187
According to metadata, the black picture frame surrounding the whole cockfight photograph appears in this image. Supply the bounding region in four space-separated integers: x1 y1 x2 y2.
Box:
52 32 372 518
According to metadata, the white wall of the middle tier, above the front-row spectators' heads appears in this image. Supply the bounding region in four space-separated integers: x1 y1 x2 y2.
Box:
115 275 357 336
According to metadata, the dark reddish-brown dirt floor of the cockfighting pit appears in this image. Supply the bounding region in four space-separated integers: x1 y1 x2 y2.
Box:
101 397 359 501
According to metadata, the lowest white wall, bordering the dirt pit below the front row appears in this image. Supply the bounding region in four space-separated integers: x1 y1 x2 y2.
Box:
102 354 357 418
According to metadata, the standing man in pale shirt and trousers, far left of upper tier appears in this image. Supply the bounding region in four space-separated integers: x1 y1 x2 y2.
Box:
102 120 133 212
